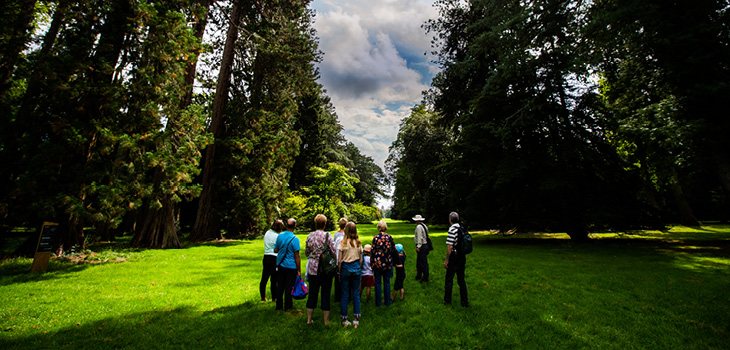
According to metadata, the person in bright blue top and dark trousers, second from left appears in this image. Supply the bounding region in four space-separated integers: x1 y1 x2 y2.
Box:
274 218 302 310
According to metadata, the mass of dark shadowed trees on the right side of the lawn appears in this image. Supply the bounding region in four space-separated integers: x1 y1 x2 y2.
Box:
387 0 730 239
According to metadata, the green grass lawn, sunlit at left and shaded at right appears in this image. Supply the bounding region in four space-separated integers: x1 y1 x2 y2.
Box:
0 222 730 349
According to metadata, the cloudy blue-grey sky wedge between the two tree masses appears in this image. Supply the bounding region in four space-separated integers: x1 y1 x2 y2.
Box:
311 0 438 171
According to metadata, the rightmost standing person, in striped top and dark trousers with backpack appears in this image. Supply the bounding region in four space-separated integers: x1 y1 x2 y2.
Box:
444 212 471 307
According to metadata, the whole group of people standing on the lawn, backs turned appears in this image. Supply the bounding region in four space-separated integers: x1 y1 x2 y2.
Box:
259 212 469 327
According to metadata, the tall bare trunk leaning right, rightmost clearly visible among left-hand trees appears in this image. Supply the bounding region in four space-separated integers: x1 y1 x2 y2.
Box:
188 0 242 241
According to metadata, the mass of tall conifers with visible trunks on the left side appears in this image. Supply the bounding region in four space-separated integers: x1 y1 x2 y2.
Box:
0 0 386 253
